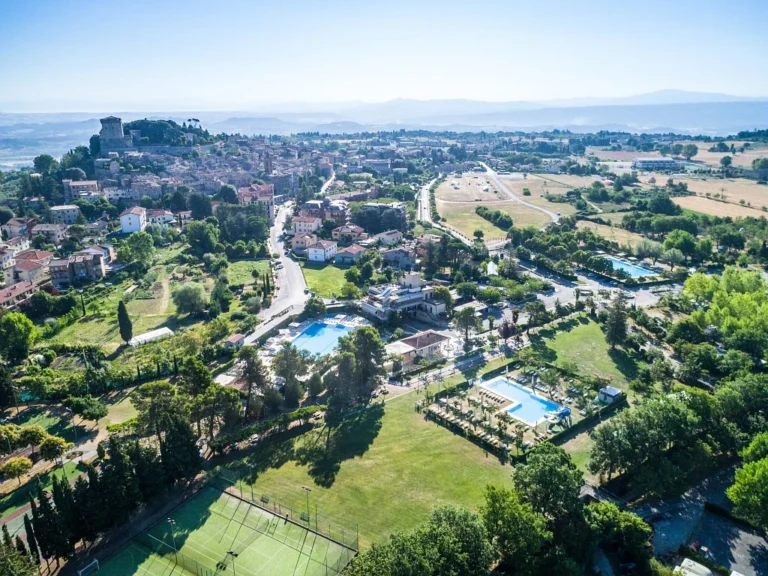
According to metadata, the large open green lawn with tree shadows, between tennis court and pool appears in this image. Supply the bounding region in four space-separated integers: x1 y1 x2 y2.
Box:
219 384 511 548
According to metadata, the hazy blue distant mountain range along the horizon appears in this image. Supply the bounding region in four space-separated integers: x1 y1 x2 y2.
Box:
0 90 768 167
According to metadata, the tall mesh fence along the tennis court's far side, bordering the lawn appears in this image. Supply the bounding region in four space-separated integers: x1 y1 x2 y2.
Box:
211 468 360 552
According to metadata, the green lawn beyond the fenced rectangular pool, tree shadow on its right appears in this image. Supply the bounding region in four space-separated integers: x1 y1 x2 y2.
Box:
545 318 639 390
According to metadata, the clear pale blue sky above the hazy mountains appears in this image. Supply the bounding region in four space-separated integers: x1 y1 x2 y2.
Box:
0 0 768 112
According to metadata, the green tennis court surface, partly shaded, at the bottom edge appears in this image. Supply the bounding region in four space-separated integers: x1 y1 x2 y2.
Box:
98 487 355 576
